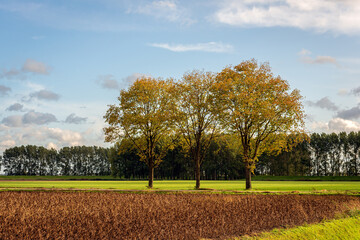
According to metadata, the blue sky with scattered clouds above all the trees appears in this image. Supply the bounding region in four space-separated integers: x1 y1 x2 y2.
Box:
0 0 360 153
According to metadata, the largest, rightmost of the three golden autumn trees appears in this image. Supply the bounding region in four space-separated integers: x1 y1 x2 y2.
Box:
216 59 305 189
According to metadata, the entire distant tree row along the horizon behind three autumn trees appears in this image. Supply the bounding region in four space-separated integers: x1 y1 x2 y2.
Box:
0 132 360 176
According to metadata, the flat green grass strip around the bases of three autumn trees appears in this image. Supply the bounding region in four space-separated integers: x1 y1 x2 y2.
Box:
0 180 360 192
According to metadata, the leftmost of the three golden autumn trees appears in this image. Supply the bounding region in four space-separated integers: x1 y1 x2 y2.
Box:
104 77 175 188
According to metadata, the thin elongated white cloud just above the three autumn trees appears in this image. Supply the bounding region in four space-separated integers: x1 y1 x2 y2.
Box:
150 42 233 53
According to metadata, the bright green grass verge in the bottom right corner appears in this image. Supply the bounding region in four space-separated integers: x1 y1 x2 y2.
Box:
239 211 360 240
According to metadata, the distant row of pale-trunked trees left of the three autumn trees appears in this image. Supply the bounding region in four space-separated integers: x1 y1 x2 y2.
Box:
1 145 110 176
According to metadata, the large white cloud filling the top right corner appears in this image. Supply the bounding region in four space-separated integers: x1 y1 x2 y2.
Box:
214 0 360 34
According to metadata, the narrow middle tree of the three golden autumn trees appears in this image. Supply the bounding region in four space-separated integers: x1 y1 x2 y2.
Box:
176 71 219 189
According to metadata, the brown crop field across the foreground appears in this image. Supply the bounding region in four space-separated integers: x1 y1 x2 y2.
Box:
0 192 360 239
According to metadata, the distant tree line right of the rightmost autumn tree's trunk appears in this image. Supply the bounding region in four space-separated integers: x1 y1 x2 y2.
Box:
256 131 360 176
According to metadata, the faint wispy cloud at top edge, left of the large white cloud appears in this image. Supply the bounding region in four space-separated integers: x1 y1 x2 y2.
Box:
128 0 195 24
